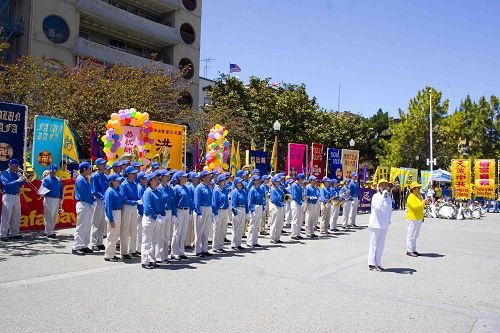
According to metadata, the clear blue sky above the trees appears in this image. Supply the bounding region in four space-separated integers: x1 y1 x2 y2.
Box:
200 0 500 116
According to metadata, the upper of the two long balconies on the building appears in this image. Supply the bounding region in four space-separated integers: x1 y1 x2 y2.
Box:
76 0 181 47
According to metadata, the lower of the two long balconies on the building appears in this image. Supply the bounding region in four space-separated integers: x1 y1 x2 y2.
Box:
73 37 176 72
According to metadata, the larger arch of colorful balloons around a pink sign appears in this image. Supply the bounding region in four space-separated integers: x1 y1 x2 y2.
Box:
101 108 154 165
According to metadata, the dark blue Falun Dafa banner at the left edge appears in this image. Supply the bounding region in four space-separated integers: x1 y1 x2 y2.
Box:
0 103 28 170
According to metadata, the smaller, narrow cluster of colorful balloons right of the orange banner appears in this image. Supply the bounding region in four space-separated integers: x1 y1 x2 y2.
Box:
203 124 231 172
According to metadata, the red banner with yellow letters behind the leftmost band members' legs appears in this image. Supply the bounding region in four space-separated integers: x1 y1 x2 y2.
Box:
0 179 76 231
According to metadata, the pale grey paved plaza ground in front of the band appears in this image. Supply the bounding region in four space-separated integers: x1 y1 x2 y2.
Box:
0 212 500 332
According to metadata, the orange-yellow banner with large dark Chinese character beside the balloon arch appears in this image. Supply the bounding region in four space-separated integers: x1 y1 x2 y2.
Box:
151 121 186 170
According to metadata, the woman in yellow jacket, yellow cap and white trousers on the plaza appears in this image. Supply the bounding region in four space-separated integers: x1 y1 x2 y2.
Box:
406 182 425 257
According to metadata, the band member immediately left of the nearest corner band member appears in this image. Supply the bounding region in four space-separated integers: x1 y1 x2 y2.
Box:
120 166 142 259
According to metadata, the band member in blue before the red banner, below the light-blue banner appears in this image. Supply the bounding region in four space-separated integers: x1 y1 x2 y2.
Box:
42 164 63 238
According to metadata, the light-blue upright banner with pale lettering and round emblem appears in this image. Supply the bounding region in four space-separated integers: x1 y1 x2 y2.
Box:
31 116 64 178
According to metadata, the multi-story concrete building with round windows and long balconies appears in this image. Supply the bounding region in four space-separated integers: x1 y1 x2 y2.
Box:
0 0 202 110
